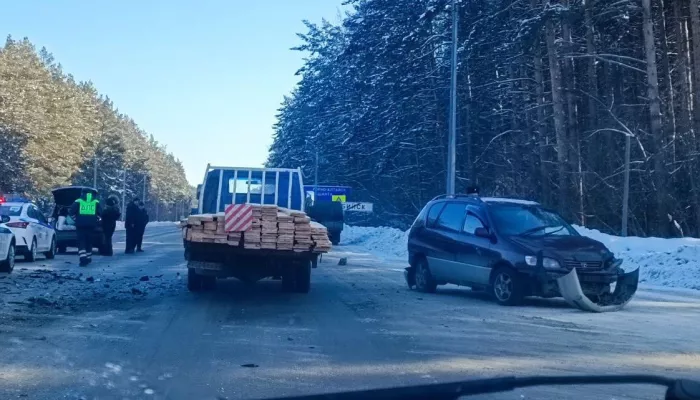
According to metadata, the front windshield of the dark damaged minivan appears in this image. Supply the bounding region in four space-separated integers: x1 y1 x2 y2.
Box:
489 203 578 236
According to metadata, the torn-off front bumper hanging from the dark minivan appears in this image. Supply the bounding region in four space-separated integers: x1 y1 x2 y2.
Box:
557 268 639 313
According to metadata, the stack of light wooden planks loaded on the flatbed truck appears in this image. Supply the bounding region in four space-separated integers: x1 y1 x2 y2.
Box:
181 204 331 253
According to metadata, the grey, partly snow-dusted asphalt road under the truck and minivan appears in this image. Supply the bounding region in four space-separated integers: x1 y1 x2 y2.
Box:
0 227 700 400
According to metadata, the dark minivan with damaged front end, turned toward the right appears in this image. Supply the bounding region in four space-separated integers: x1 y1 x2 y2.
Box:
405 195 624 305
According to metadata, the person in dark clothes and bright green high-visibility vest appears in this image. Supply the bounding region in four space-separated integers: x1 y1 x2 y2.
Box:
70 189 102 267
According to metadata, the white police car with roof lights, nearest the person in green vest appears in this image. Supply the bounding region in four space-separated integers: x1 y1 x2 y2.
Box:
0 198 56 261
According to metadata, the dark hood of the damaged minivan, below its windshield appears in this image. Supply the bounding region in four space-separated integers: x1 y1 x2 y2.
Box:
510 235 612 259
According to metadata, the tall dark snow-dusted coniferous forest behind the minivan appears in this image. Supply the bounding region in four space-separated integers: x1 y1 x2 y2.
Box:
268 0 700 237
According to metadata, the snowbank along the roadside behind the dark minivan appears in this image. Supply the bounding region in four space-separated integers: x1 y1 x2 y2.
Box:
341 225 700 290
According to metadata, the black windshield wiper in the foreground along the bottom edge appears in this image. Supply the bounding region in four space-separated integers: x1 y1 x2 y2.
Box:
264 375 700 400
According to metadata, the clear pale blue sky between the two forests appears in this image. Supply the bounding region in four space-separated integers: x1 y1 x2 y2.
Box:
0 0 342 184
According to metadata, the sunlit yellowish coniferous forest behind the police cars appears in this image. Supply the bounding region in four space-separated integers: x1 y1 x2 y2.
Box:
0 37 192 219
